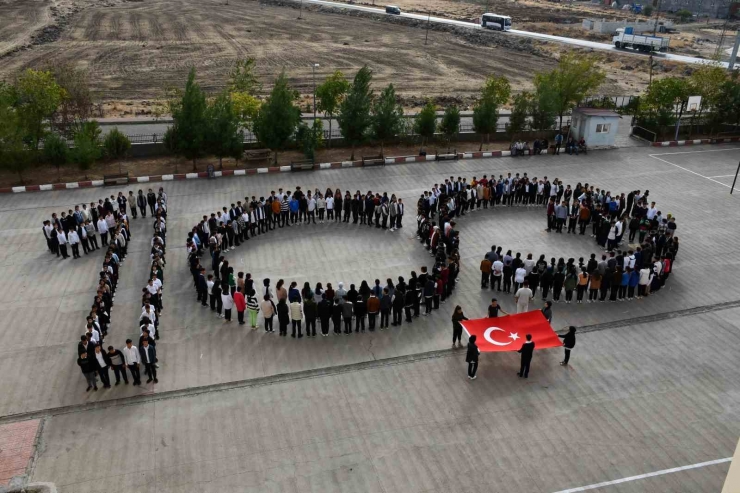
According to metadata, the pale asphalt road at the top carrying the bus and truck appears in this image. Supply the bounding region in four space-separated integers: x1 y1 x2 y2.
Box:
306 0 727 67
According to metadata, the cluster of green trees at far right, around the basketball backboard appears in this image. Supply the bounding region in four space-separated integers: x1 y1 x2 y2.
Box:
637 65 740 135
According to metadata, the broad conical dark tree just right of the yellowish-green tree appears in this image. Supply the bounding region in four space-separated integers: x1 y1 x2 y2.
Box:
254 72 301 164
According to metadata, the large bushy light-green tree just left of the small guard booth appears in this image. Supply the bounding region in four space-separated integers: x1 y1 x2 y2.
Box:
535 53 606 129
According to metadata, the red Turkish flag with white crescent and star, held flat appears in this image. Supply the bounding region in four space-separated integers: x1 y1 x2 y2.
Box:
462 310 563 352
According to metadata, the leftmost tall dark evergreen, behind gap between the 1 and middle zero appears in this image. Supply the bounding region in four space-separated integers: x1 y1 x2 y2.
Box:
171 68 206 171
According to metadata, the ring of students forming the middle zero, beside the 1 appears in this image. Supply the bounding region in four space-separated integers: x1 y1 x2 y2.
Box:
186 187 459 338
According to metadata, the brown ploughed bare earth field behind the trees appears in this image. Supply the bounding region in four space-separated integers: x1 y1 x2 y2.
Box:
0 0 692 112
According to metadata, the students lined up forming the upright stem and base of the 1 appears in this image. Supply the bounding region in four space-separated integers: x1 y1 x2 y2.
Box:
77 188 167 392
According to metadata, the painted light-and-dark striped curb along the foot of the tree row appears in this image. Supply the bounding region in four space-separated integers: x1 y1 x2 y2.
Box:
0 148 548 193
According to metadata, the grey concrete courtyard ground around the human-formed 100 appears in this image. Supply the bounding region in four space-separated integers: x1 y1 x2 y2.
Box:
0 145 740 493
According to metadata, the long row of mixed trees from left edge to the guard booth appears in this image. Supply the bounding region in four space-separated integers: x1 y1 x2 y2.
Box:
0 55 604 174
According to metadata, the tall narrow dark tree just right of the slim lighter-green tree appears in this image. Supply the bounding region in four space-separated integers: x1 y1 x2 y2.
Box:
337 65 373 160
